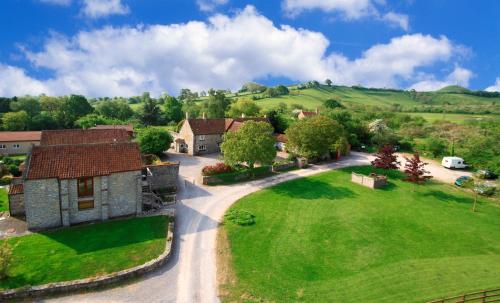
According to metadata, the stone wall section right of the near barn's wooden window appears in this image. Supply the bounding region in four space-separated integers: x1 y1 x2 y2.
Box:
107 171 142 218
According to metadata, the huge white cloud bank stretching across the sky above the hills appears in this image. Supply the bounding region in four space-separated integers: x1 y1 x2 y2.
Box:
0 6 459 96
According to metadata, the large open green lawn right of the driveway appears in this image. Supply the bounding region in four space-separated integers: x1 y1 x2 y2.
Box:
219 167 500 302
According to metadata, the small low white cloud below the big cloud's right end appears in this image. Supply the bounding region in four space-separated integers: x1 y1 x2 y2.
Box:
411 66 474 91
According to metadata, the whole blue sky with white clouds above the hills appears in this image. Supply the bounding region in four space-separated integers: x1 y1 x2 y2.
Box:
0 0 500 97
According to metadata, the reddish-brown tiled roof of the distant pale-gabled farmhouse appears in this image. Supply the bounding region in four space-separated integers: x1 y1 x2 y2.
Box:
188 118 268 135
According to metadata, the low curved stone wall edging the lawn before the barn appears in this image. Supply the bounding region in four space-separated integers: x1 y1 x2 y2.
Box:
0 222 174 302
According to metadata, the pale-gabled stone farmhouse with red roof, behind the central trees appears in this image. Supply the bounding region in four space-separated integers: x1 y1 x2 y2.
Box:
172 118 269 156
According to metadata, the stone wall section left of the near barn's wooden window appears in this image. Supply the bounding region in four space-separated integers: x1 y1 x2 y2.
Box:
24 179 62 229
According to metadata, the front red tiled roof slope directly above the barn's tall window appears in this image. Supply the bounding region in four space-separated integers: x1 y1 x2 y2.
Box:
26 142 142 180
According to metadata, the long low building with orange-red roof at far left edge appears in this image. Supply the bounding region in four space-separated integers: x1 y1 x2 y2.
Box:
0 131 41 155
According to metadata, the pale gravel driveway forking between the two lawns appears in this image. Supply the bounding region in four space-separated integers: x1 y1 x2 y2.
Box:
47 153 460 303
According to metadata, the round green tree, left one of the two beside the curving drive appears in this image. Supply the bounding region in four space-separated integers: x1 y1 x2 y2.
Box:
221 121 276 168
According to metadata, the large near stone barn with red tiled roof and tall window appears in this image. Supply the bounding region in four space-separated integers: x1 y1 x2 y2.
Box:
9 129 179 229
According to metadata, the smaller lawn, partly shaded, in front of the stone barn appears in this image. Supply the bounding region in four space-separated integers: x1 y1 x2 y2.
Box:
0 216 168 289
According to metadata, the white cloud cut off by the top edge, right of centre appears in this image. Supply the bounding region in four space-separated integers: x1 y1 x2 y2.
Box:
282 0 376 19
